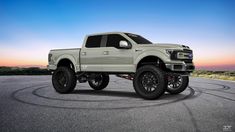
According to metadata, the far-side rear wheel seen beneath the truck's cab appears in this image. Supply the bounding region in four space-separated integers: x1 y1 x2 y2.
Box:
88 74 109 90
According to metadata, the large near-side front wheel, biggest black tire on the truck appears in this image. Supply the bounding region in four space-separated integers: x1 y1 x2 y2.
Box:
133 65 166 99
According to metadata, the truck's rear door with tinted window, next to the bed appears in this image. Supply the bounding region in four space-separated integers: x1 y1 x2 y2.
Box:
80 35 105 72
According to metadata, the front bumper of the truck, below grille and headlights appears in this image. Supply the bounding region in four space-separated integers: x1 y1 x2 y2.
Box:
165 62 195 72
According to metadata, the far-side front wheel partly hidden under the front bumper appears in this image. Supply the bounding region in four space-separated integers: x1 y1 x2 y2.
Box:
166 74 189 94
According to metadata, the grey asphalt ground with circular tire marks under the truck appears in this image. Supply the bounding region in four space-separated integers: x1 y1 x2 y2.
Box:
0 76 235 132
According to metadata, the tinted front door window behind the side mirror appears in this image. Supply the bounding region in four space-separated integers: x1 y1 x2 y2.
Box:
106 34 127 48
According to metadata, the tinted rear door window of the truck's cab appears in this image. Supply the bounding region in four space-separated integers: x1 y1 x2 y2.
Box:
86 35 102 48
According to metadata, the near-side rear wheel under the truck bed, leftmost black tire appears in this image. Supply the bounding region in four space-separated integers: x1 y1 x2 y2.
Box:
52 67 77 93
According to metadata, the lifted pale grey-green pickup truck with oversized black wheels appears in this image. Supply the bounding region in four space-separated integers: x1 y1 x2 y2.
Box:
48 32 194 99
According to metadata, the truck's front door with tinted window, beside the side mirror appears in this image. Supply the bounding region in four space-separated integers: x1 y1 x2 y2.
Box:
101 34 135 72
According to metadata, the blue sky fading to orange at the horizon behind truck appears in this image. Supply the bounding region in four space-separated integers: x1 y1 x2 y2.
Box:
0 0 235 70
